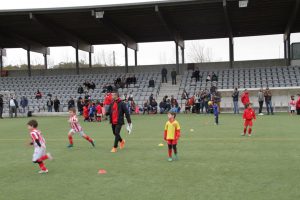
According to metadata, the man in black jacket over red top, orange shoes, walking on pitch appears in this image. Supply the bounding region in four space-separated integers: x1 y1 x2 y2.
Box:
107 91 131 153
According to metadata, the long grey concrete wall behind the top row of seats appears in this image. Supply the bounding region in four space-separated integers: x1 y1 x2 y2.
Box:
4 59 285 77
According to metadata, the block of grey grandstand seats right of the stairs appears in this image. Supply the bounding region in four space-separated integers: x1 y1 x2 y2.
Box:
178 66 300 95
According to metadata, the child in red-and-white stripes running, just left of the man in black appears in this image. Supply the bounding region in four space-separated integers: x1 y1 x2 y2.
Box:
68 108 95 148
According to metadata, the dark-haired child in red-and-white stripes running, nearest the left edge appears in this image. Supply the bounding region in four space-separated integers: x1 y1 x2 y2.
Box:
27 120 53 174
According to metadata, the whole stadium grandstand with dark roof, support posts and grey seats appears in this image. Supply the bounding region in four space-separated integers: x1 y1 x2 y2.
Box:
0 0 300 116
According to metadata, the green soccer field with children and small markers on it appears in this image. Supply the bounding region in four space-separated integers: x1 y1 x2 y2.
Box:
0 114 300 200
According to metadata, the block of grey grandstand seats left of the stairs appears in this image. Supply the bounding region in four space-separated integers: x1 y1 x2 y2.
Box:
0 72 161 112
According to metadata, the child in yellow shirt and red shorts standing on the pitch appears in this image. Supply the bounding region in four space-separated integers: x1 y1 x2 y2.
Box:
164 112 180 162
